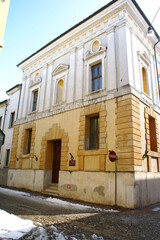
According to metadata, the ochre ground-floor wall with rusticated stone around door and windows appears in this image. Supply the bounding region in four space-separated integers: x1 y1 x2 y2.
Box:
10 94 160 172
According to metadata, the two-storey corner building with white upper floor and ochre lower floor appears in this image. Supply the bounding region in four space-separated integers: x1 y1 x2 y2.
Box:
8 0 160 208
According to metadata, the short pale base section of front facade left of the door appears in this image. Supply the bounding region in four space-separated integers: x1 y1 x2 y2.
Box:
7 169 44 192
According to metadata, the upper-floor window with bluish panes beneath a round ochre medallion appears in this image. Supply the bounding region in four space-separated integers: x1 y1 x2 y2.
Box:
92 63 102 91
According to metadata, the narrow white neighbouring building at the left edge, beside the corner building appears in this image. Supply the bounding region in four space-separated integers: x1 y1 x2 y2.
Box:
0 84 21 186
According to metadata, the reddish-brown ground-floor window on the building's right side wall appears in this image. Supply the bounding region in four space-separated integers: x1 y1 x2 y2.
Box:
149 116 157 152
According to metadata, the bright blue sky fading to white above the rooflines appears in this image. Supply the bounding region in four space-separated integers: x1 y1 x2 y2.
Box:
0 0 160 101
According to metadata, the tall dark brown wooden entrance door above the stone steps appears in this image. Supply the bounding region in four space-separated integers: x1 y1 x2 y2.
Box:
52 140 61 183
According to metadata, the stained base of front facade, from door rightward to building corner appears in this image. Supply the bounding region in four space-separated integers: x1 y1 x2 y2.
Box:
59 171 135 208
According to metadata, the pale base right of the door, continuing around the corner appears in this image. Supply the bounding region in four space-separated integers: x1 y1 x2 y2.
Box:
59 171 160 208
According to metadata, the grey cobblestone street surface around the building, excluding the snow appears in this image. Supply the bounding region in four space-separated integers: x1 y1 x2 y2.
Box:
0 188 160 240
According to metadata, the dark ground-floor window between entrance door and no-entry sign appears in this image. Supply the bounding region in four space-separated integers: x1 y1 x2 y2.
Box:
85 116 99 150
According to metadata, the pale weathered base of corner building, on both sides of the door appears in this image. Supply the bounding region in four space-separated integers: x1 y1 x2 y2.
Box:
6 169 160 208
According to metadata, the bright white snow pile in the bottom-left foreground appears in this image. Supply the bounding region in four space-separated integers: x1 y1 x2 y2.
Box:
0 210 104 240
